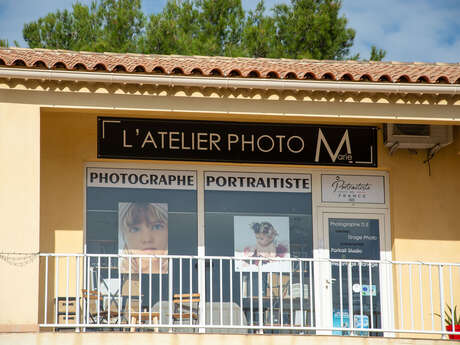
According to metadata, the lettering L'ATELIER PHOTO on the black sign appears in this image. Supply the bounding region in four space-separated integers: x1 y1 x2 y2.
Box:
123 130 305 153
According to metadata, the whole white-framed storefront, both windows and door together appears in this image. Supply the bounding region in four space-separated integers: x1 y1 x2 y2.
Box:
85 164 391 334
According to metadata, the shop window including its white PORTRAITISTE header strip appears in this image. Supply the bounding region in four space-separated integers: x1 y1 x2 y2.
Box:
204 172 313 301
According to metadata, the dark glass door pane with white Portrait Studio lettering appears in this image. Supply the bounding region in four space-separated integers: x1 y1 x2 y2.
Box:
328 218 381 335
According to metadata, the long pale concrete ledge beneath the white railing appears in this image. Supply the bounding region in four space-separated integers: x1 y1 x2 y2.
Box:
0 332 448 345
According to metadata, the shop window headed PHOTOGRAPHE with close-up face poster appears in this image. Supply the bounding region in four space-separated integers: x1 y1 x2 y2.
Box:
86 168 198 309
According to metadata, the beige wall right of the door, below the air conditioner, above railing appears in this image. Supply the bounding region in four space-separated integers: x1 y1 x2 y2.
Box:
379 127 460 262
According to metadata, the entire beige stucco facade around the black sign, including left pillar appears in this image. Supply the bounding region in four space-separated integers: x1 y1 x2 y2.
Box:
0 79 460 332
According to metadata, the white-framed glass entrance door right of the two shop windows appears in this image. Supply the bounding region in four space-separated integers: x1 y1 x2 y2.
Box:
320 208 391 336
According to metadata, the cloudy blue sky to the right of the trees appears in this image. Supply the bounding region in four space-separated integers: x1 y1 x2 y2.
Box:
342 0 460 62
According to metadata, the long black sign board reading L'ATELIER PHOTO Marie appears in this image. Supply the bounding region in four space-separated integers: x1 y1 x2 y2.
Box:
98 117 377 167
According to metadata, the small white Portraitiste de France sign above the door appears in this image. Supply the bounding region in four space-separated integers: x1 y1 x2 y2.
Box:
321 174 385 204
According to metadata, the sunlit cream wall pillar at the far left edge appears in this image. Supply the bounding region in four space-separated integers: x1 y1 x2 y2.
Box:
0 103 40 332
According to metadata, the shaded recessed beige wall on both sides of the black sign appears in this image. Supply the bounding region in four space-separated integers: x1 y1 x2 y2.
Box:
41 110 460 262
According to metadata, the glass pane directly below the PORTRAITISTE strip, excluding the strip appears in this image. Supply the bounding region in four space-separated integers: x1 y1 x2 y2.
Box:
205 174 314 327
